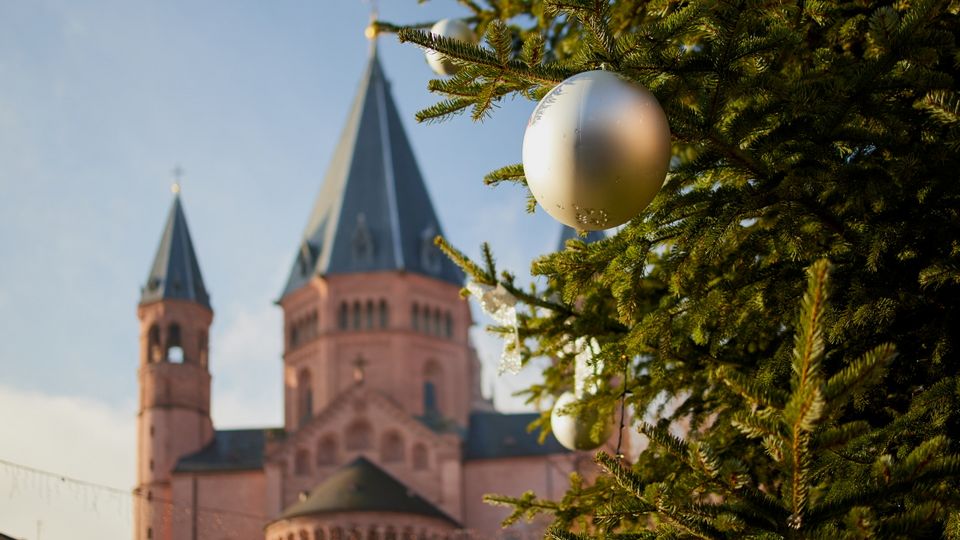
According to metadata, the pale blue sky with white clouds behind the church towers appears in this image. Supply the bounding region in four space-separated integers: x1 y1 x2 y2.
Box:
0 0 560 538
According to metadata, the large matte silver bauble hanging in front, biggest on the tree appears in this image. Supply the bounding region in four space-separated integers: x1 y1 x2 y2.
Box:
523 71 670 231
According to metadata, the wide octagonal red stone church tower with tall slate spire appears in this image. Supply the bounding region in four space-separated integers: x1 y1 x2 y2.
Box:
280 43 481 433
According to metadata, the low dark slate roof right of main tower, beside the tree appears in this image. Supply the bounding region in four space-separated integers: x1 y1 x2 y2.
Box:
464 412 569 459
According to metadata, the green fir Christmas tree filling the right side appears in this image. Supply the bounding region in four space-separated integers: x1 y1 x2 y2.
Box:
378 0 960 539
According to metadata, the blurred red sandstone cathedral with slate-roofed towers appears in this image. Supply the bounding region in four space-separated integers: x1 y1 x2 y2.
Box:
133 46 584 540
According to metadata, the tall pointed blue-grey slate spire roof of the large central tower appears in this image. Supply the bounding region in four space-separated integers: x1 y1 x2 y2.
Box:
282 48 463 296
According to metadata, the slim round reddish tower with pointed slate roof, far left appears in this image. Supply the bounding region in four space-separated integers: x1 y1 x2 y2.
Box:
134 189 213 540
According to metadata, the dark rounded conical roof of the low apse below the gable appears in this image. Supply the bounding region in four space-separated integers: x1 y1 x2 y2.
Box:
280 457 459 525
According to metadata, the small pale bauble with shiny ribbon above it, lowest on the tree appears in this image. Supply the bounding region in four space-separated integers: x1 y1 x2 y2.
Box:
550 338 614 450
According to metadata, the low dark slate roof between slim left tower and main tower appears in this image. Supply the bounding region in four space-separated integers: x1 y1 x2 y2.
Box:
173 428 272 472
